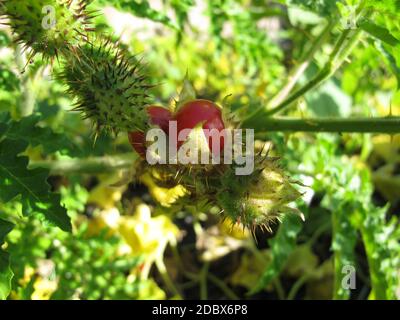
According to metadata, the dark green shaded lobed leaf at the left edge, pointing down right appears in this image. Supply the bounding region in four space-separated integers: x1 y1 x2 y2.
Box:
0 139 72 231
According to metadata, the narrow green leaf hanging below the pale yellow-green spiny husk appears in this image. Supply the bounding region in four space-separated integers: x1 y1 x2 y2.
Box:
249 215 303 294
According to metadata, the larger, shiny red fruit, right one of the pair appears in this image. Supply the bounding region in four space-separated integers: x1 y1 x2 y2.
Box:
173 99 225 153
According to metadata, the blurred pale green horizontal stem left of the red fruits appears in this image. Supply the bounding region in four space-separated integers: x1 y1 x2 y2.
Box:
29 152 138 175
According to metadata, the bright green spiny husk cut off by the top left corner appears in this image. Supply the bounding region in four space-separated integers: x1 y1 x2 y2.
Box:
0 0 92 59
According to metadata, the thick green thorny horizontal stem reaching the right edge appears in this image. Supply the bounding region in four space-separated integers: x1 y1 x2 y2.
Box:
254 117 400 136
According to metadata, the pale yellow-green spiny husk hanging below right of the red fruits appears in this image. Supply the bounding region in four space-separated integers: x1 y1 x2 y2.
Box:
217 155 303 231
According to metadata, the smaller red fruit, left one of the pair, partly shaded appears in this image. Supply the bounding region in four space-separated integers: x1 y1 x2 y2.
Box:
128 106 172 158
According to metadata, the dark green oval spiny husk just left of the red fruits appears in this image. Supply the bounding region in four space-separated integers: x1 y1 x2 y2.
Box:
58 39 151 133
